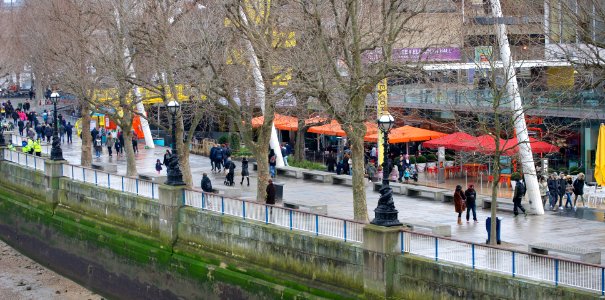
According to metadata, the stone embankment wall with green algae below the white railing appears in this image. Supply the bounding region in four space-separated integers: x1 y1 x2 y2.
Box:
0 161 598 299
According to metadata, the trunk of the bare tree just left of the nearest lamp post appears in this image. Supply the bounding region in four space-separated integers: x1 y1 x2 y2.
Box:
345 123 368 222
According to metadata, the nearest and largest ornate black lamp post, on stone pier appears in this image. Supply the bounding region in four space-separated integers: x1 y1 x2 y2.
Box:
371 112 401 227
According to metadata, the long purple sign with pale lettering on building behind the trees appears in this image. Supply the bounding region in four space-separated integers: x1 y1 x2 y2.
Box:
362 47 462 63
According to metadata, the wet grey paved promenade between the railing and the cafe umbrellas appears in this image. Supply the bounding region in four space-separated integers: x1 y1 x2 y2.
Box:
48 135 605 258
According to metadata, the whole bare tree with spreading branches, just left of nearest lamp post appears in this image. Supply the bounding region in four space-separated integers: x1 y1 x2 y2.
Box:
291 0 444 221
